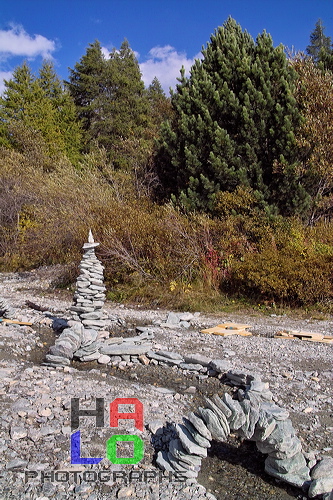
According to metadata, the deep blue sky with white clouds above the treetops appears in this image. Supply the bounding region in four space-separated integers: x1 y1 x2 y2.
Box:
0 0 333 93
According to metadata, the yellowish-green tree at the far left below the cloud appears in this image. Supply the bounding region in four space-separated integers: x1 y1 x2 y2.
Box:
0 62 81 161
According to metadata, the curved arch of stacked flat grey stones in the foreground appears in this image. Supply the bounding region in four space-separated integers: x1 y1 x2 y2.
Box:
156 372 333 498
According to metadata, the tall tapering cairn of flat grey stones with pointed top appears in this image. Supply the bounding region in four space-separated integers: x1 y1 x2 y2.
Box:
70 231 106 330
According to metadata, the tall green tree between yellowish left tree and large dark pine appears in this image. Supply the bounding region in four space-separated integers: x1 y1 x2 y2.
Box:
67 40 148 168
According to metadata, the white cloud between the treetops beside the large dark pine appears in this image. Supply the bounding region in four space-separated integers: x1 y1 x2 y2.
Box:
140 45 202 94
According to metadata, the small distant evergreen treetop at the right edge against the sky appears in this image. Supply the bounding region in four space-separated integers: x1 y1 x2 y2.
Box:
306 19 333 70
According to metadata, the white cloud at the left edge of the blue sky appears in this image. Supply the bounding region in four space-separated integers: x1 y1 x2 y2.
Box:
0 25 56 59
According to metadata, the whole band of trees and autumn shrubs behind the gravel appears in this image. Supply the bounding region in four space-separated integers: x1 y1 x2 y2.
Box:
0 18 333 311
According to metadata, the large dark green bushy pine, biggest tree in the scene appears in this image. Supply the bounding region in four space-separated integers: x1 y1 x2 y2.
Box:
156 18 309 214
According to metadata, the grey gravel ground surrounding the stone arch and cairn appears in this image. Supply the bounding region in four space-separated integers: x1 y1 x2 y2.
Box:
0 266 333 500
